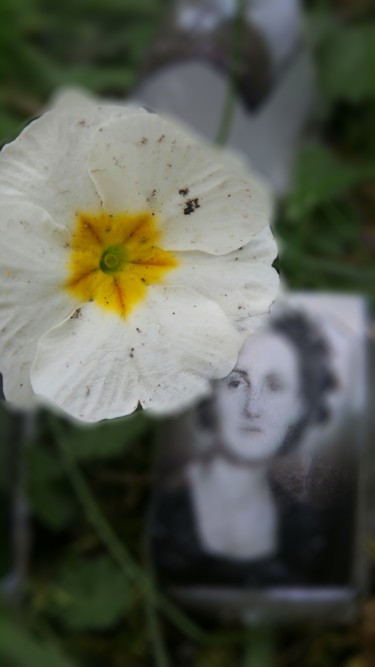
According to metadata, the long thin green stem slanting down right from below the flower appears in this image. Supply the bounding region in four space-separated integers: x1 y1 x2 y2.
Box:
53 419 207 642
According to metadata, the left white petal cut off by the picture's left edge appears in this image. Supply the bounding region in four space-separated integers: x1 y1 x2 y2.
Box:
0 201 79 406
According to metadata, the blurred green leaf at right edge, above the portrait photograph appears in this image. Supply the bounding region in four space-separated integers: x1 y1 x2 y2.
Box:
286 145 375 219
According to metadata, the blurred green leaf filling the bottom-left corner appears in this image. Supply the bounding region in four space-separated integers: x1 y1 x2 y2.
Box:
0 618 81 667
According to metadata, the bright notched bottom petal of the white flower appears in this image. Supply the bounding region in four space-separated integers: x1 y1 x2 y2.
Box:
31 286 242 421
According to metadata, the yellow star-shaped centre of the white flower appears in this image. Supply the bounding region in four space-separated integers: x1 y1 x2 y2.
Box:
65 212 178 318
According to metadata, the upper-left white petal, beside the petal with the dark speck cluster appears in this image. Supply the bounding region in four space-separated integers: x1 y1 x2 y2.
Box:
0 101 142 228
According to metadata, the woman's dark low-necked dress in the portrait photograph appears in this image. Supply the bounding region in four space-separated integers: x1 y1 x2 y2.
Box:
150 474 355 589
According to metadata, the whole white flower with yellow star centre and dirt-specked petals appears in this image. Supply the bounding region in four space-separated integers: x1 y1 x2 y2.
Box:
0 90 278 421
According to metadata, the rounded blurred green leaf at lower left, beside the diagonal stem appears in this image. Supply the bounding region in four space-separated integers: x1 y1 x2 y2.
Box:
50 556 131 630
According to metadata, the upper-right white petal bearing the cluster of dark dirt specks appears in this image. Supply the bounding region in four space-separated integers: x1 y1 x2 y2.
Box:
90 114 270 254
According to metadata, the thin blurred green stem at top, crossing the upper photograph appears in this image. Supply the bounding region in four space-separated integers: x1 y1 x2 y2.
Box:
215 0 246 146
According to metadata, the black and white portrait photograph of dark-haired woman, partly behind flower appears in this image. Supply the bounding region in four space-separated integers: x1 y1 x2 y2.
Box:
150 294 366 590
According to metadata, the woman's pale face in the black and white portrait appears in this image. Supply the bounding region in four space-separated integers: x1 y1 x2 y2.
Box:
216 333 302 462
